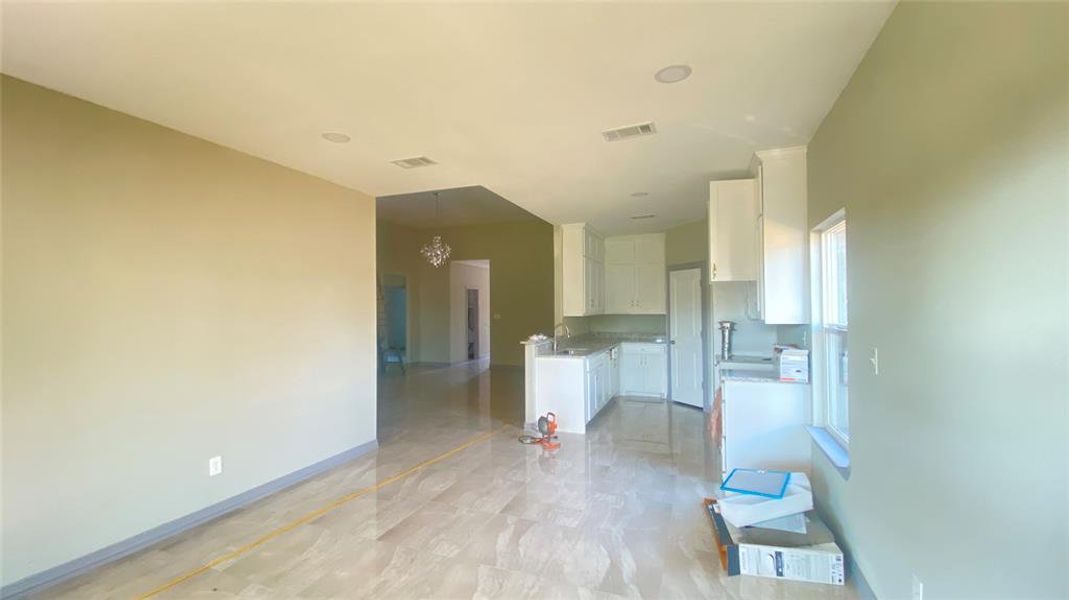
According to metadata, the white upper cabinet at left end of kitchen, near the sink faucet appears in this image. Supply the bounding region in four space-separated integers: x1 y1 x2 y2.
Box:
560 222 605 317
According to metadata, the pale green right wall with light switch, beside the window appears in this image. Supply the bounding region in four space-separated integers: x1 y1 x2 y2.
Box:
808 2 1069 598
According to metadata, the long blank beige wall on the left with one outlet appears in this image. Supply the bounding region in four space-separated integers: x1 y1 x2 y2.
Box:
0 77 375 584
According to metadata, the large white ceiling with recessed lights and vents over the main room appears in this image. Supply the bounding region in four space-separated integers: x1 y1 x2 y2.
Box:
0 1 894 233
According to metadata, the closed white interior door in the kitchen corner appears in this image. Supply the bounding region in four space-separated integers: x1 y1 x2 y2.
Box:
668 268 704 407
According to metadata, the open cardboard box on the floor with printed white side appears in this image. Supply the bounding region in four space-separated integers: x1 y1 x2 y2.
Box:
706 498 846 585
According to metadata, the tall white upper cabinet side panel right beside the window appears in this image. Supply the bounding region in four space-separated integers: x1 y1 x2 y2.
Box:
754 147 809 325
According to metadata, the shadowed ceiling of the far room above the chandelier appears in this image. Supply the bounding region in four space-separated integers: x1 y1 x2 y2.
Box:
375 186 538 229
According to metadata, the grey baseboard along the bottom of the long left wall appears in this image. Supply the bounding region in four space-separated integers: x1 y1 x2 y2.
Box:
0 440 378 600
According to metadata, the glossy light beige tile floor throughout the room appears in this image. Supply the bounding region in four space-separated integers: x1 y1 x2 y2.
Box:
37 361 856 600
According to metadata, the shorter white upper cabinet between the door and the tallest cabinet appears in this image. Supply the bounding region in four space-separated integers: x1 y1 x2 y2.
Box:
709 179 758 281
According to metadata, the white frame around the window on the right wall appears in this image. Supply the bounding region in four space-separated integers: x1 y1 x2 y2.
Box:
809 209 850 449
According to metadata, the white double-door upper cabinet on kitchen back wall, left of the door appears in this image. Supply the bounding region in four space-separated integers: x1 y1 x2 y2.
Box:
605 233 666 314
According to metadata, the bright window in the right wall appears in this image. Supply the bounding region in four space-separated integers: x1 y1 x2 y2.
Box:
812 211 850 446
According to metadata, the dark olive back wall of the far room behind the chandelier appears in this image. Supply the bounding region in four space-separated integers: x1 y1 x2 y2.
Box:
378 216 554 366
